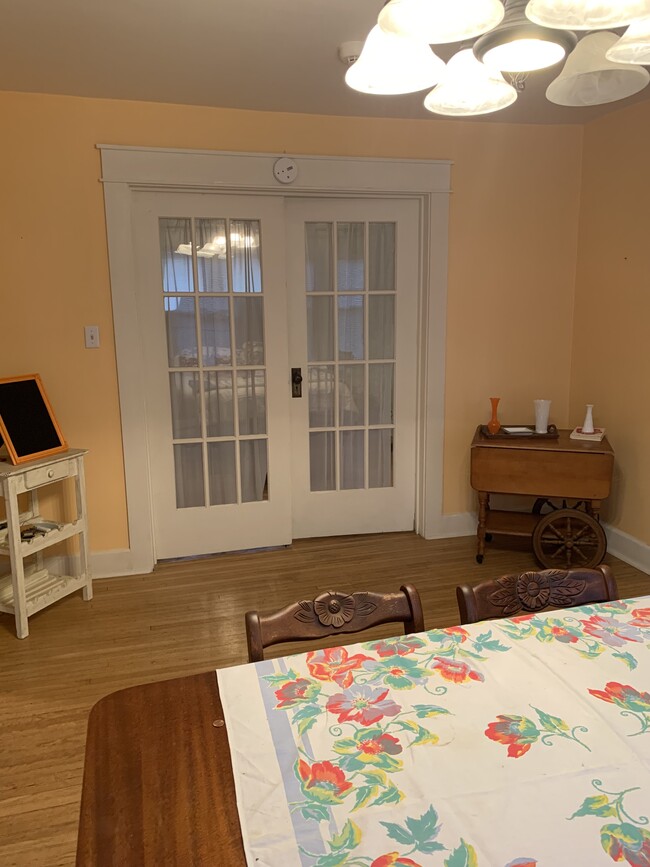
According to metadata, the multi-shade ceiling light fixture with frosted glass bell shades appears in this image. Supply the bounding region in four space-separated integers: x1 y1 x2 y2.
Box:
346 0 650 116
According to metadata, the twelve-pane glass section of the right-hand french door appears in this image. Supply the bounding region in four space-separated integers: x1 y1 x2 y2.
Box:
304 221 396 491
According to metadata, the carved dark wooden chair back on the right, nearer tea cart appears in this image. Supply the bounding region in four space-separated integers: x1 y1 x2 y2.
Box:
456 564 618 623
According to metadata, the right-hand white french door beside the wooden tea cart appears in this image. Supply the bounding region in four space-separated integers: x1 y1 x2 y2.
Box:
287 199 419 538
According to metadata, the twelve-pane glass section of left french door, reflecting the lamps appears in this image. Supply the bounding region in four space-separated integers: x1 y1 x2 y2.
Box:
159 216 270 509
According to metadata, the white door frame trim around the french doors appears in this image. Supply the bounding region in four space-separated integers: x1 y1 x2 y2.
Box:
97 145 451 574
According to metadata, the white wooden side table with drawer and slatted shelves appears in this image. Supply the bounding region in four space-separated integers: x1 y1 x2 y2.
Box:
0 449 93 638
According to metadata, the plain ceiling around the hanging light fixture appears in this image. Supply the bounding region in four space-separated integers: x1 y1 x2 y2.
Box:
0 0 650 123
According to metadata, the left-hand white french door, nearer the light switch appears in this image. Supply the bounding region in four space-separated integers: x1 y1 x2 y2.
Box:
134 193 291 560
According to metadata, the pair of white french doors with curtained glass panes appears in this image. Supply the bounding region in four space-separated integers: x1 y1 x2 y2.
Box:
133 192 419 560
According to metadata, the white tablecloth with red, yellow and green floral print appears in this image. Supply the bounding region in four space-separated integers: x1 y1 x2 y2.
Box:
217 596 650 867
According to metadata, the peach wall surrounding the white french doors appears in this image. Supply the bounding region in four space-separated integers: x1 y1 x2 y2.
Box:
0 86 582 551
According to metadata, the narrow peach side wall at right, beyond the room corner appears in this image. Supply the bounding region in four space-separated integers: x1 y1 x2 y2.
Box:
570 102 650 544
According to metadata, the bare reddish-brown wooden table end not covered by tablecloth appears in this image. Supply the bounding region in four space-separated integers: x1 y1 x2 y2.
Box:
76 671 246 867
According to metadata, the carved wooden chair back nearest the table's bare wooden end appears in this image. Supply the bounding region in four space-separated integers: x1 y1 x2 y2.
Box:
245 584 424 662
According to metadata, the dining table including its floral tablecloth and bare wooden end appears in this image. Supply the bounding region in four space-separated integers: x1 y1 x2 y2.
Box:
76 588 650 867
